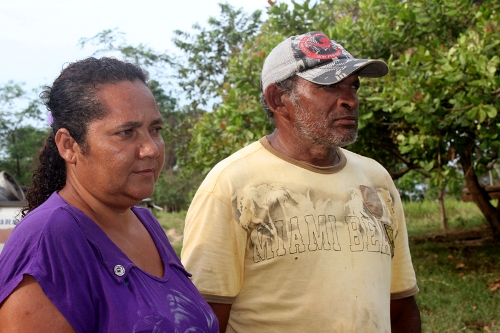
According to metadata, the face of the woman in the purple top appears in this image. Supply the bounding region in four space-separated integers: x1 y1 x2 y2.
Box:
74 80 165 208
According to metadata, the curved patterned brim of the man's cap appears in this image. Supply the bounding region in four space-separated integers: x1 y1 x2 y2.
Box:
297 59 389 85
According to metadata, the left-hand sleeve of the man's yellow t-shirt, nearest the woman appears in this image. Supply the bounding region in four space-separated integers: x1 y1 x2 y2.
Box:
181 190 247 304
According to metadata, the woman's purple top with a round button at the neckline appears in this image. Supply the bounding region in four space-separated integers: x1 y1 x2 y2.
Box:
0 193 219 333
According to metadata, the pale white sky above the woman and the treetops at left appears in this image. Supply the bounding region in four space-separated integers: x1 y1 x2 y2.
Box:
0 0 282 90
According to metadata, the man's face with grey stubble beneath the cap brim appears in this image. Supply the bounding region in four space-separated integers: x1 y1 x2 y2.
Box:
288 74 360 148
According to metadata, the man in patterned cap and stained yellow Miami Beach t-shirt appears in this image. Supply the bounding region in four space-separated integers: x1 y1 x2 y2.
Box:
181 32 420 333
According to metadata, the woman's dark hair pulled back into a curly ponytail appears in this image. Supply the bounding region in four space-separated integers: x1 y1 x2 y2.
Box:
22 58 147 217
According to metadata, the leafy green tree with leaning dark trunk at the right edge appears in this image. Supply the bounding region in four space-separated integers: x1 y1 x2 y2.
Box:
356 1 500 240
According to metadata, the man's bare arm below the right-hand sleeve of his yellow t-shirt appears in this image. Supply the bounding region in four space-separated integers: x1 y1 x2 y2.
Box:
391 296 422 333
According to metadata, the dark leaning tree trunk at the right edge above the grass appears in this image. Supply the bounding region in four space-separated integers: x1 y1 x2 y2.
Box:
460 147 500 241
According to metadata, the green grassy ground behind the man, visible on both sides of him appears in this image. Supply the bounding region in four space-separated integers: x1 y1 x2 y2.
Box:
155 199 500 333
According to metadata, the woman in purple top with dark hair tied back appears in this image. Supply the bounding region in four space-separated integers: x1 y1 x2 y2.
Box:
0 58 218 333
